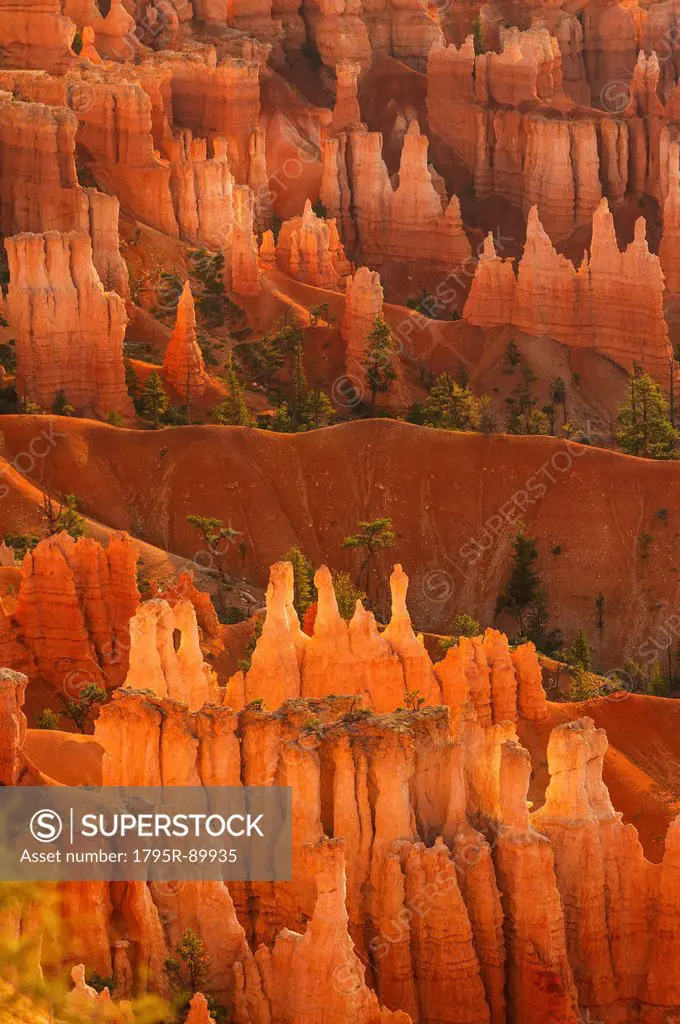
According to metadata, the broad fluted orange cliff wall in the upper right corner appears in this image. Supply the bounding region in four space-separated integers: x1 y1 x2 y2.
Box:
427 24 677 242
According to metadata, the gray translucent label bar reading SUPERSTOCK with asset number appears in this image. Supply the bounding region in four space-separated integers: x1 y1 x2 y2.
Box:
0 785 293 882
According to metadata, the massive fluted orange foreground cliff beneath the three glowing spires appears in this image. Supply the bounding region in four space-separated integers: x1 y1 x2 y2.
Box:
0 622 680 1024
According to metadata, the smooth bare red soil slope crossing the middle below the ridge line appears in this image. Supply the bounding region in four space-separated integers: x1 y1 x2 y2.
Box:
0 416 680 668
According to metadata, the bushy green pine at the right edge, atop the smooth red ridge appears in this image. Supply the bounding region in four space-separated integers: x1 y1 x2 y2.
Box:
617 366 679 459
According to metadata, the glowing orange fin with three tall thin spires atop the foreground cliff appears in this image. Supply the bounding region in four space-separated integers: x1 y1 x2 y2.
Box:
228 562 547 726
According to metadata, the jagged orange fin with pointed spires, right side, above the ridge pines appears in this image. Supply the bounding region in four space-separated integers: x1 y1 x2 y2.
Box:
463 201 675 383
